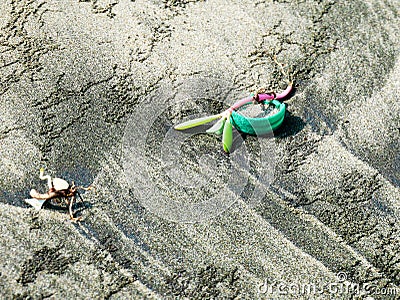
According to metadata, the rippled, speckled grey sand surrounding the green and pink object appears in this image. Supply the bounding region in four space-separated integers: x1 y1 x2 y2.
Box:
0 0 400 299
